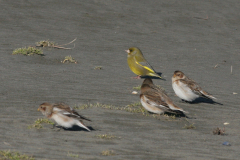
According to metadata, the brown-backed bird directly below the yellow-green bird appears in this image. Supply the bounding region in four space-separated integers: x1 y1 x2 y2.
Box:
140 78 187 114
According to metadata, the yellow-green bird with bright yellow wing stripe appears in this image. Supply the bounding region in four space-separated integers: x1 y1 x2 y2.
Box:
126 47 163 79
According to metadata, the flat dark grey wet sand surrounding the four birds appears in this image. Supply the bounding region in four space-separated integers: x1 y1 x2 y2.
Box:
0 0 240 160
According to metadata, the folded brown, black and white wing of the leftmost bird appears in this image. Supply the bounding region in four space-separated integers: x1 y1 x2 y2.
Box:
53 103 91 121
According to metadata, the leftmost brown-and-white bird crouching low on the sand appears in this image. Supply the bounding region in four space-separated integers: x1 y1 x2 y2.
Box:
38 103 91 131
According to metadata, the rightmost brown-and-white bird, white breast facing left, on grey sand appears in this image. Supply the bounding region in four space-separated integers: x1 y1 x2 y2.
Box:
172 71 216 102
